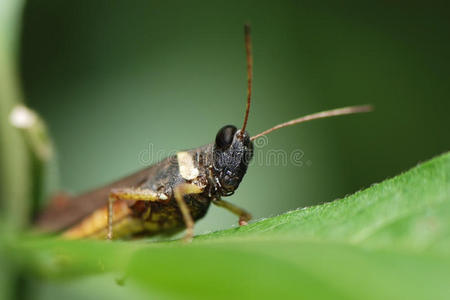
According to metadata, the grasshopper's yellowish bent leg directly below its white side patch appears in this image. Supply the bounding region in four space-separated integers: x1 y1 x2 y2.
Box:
174 183 203 242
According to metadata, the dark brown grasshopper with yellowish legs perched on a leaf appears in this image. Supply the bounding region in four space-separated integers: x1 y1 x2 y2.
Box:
37 25 372 241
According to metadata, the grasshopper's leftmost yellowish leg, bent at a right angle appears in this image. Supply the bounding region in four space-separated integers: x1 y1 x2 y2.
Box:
107 188 167 240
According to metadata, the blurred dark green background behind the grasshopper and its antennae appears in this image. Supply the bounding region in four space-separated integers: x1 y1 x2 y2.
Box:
20 0 450 233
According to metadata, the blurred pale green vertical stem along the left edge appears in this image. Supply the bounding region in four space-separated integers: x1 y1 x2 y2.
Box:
0 0 27 231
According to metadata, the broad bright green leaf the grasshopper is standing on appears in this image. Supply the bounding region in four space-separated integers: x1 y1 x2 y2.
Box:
4 153 450 299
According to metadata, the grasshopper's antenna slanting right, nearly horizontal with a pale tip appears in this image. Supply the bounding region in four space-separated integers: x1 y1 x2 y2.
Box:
250 105 373 141
